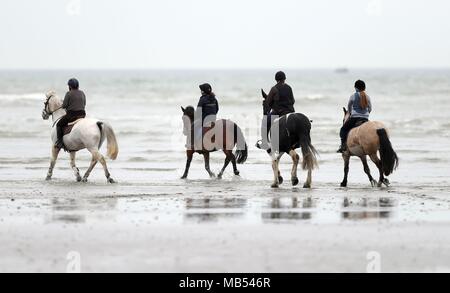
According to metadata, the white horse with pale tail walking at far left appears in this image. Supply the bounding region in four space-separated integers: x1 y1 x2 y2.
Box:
42 91 119 183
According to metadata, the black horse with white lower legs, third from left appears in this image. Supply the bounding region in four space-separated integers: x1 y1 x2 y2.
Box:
262 90 317 188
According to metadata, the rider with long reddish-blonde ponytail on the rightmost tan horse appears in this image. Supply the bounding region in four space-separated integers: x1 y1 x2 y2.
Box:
338 80 372 153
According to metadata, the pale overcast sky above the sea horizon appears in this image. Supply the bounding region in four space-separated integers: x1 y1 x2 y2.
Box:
0 0 450 69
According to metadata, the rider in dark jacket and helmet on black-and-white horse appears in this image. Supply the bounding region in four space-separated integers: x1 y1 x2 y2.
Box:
256 71 295 149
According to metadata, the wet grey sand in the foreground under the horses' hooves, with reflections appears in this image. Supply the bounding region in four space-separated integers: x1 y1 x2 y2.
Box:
0 160 450 272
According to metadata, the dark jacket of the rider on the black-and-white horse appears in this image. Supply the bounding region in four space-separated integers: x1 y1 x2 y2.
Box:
267 83 295 116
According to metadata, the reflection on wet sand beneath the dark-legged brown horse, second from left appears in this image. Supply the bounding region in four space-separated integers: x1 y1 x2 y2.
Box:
184 198 247 222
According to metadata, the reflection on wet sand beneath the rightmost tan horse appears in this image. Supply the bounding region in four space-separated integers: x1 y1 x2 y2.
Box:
341 197 396 220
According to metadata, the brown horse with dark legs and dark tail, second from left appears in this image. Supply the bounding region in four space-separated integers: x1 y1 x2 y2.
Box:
181 106 248 179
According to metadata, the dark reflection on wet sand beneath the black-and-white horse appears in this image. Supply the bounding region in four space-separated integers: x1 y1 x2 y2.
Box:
261 197 315 221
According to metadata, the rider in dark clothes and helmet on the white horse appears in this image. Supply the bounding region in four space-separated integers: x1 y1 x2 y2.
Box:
55 78 86 148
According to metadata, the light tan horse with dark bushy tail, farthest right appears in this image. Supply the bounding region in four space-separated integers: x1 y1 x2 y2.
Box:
341 108 398 187
